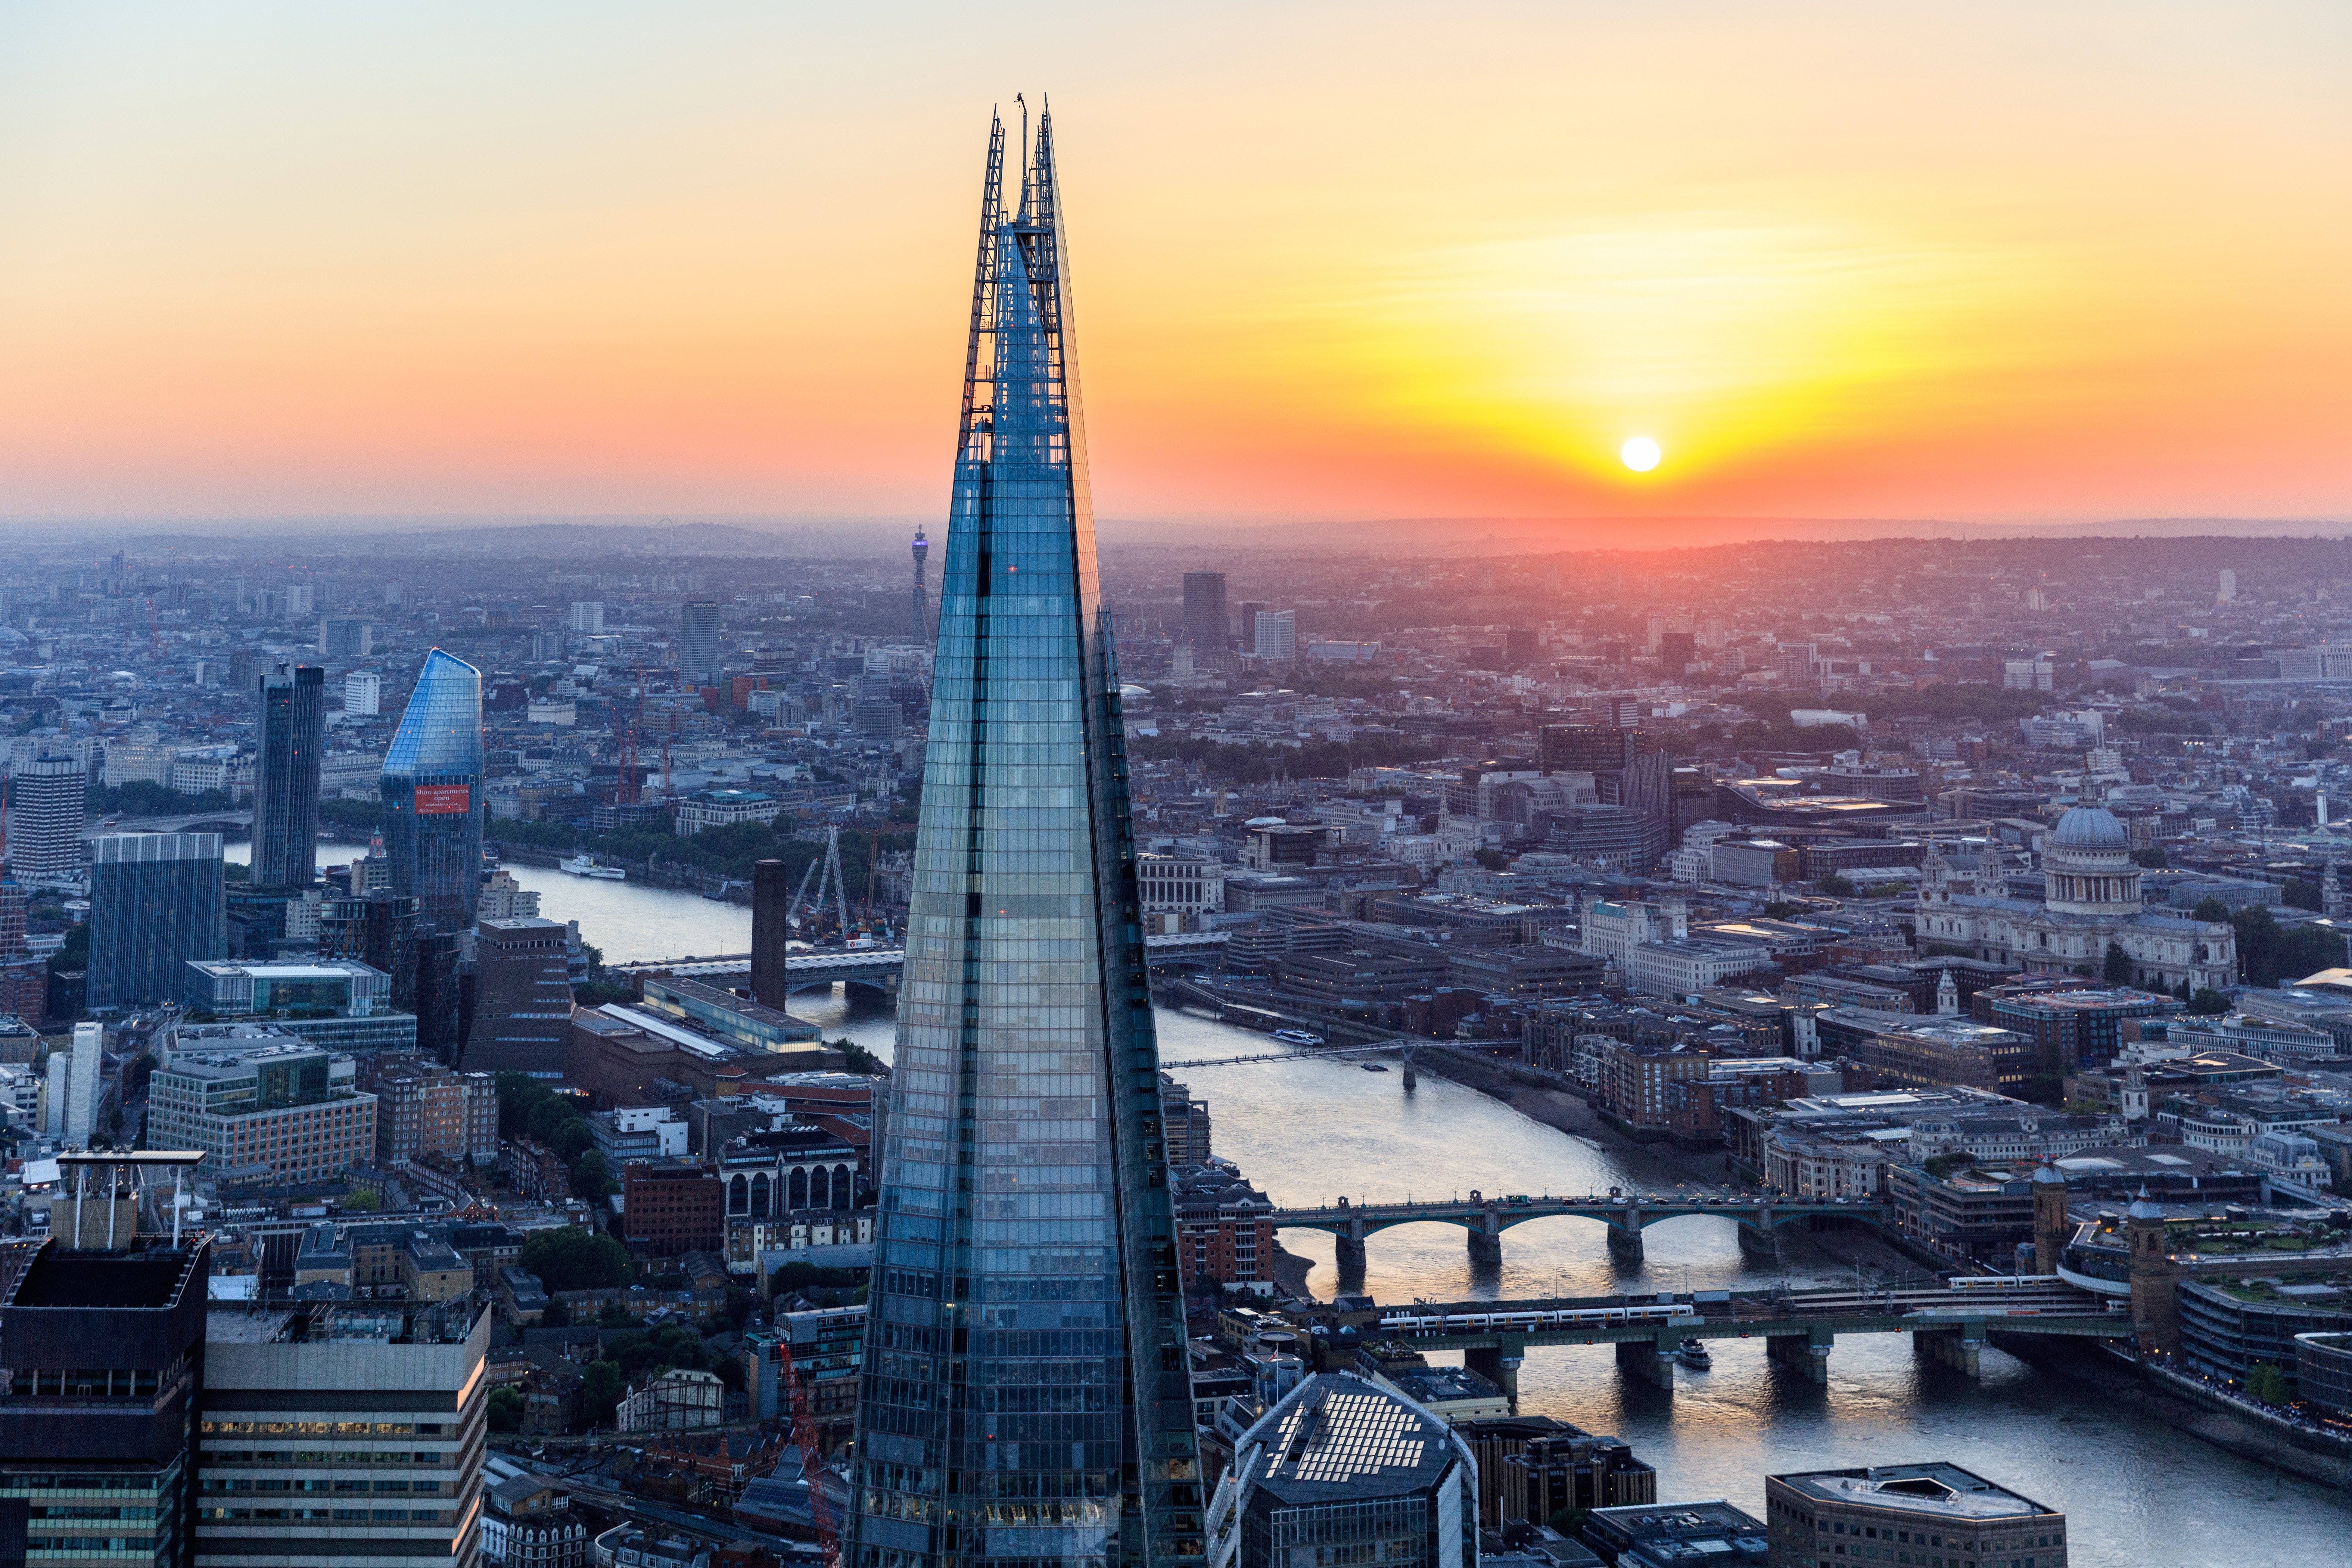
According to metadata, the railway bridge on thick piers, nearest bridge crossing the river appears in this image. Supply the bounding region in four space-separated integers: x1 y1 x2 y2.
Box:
1362 1274 2131 1408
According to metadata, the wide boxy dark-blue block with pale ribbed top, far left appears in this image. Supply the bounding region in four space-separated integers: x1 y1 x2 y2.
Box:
89 832 228 1013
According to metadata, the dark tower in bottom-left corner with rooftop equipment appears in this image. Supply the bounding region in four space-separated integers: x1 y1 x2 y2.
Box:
0 1222 212 1568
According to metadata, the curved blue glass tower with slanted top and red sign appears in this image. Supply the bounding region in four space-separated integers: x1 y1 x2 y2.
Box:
379 649 482 933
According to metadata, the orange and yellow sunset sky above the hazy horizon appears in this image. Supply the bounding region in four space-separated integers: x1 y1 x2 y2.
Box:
0 0 2352 533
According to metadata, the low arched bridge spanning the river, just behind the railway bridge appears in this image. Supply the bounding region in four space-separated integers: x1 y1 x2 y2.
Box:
1272 1192 1884 1267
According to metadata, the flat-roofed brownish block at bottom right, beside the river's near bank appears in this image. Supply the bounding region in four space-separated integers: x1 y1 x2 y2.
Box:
1764 1460 2068 1568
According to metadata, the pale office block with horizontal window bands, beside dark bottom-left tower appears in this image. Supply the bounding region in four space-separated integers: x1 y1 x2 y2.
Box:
193 1300 492 1568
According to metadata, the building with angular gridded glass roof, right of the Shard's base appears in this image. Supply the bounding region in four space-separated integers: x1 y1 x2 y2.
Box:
1209 1373 1477 1568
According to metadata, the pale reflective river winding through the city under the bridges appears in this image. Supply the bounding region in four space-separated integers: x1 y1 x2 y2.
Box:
280 846 2352 1568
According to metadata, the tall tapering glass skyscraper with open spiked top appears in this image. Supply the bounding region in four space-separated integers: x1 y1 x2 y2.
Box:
844 115 1204 1568
